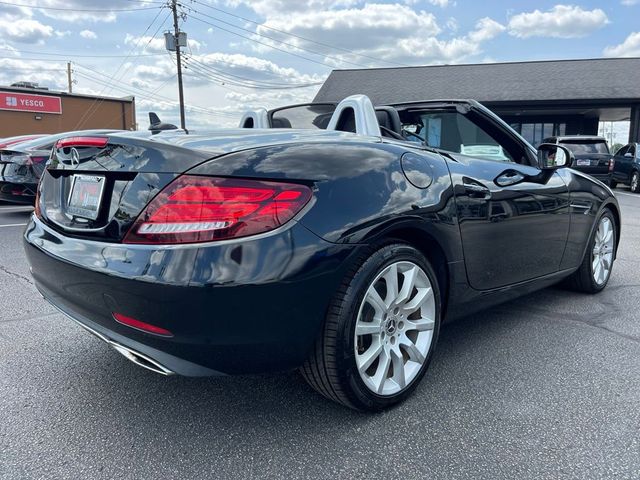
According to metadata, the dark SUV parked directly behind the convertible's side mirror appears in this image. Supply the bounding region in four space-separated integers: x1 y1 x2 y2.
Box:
542 135 613 183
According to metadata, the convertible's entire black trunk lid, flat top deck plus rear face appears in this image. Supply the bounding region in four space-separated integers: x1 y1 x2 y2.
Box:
37 129 362 242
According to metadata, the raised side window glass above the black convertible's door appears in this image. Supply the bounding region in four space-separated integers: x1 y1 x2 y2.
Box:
409 111 514 162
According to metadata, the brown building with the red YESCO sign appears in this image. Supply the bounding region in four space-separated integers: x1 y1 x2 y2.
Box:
0 87 136 138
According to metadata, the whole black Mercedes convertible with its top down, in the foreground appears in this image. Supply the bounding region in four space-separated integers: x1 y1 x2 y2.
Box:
24 96 620 410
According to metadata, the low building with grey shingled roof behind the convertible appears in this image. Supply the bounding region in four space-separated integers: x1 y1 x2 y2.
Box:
314 58 640 144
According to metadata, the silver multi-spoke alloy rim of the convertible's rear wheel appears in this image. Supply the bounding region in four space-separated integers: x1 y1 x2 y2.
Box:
354 261 436 395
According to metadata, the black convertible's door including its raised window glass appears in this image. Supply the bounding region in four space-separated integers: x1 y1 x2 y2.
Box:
422 109 569 290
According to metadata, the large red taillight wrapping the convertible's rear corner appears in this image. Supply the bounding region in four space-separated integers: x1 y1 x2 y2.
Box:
124 175 311 244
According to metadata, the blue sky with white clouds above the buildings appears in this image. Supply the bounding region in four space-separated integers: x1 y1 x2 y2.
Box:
0 0 640 133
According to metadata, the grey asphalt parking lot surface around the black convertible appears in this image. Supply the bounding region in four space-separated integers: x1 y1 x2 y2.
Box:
0 193 640 479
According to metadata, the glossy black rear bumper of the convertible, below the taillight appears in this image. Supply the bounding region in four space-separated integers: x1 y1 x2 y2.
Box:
24 217 356 375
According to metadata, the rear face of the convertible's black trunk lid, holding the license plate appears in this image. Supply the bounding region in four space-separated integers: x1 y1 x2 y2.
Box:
37 136 211 241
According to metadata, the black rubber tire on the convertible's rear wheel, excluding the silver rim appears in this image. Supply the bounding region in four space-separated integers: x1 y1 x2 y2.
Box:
300 243 441 412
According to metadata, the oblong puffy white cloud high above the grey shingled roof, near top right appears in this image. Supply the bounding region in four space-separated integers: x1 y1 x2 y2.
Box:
508 5 609 38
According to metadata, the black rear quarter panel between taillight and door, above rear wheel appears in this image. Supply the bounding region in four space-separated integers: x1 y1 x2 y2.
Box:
189 142 462 262
